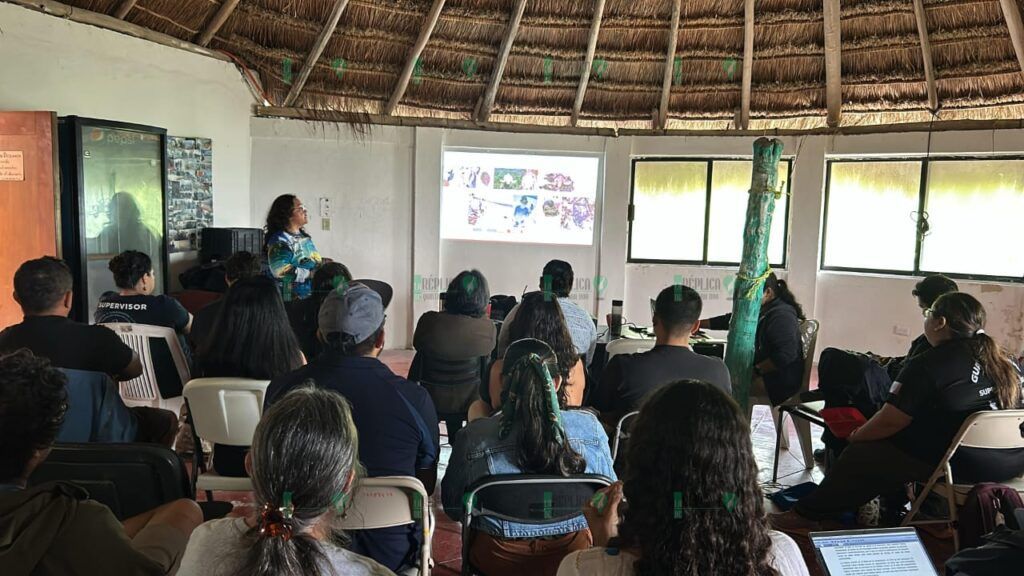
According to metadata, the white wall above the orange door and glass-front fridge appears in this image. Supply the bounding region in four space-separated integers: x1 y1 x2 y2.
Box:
0 3 253 282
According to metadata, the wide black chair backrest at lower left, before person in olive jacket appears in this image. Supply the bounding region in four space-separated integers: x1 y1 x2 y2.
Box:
29 443 193 520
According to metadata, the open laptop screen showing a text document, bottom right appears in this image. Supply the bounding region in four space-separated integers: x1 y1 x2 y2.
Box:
810 528 938 576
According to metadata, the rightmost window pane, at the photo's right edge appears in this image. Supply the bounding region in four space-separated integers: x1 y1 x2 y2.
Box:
921 160 1024 278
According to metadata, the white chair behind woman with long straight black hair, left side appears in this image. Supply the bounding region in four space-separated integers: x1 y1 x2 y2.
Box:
184 378 270 494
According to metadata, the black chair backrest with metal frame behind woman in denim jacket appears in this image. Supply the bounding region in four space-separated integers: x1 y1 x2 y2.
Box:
462 474 611 576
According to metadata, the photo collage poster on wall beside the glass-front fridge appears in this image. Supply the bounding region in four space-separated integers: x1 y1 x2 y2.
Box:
167 136 213 253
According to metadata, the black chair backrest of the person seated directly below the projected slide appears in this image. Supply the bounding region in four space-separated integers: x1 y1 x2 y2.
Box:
409 353 488 434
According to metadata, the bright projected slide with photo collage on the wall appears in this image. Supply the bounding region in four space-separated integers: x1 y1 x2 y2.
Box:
441 152 600 245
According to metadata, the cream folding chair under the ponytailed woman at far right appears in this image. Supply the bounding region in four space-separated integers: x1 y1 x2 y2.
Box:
902 410 1024 551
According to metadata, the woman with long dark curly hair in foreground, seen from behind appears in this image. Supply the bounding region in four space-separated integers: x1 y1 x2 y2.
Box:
558 380 808 576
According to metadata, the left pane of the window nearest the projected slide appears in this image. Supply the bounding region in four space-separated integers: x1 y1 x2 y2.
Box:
630 162 708 260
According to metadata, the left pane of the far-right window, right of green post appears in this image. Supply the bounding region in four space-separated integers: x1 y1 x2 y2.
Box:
824 162 921 272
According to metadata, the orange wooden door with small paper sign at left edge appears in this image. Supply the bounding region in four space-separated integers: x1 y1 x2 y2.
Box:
0 112 58 328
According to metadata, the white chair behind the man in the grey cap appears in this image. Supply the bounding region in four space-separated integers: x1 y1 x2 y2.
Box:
336 476 434 576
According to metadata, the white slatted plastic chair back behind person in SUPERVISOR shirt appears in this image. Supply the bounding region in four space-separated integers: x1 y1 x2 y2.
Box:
103 323 191 402
